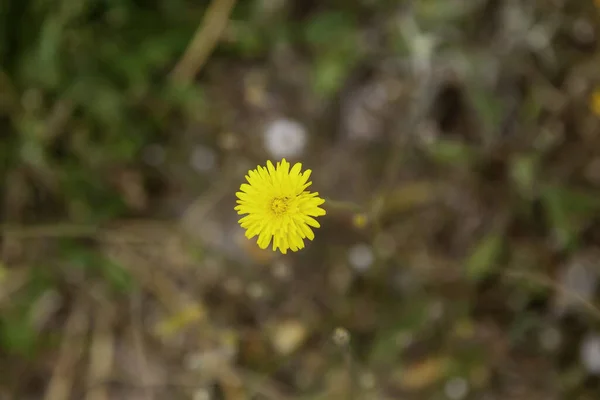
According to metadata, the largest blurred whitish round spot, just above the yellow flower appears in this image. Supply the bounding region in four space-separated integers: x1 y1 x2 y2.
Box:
264 118 308 158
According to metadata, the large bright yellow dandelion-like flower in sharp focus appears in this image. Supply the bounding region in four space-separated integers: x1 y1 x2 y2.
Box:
235 158 325 254
